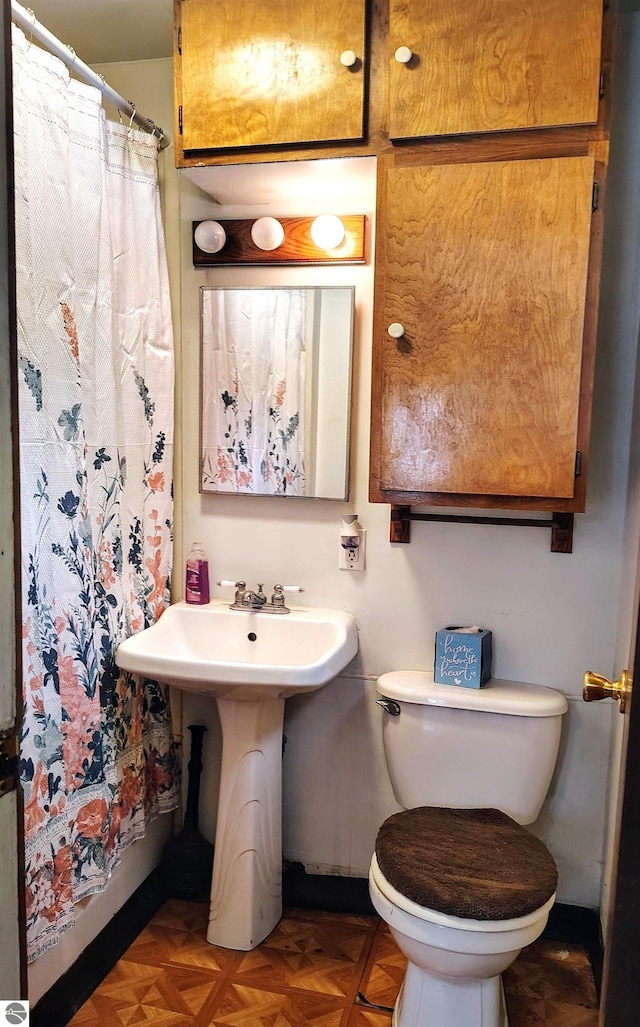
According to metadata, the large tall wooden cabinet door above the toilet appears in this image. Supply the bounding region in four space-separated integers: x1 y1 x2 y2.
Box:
371 157 594 506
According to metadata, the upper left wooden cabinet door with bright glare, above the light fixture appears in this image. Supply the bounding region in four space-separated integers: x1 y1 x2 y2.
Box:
178 0 365 150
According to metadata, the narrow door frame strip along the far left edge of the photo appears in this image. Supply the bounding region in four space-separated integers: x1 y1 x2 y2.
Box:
0 4 26 1007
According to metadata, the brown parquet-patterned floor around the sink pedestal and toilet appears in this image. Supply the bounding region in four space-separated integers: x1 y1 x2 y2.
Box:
71 900 598 1027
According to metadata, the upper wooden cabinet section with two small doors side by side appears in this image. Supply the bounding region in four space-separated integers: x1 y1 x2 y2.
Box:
175 0 602 166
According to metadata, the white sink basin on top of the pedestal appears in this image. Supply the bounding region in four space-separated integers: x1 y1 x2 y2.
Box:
115 602 357 700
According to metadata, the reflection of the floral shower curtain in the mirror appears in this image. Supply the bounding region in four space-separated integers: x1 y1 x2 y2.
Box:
201 289 307 496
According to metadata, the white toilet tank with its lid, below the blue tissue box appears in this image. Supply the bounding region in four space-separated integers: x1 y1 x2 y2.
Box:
376 671 567 824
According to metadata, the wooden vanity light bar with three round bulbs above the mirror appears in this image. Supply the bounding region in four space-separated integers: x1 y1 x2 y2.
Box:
192 214 366 267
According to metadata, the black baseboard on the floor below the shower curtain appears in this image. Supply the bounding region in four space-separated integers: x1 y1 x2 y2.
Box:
30 870 168 1027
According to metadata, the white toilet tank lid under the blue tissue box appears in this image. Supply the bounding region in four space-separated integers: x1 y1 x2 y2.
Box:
376 671 567 717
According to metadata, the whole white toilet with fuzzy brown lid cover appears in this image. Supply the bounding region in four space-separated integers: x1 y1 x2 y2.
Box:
369 671 567 1027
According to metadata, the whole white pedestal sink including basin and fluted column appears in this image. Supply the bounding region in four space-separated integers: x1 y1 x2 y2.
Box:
116 602 357 951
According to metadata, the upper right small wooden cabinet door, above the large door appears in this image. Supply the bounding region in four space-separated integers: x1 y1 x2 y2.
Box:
388 0 603 139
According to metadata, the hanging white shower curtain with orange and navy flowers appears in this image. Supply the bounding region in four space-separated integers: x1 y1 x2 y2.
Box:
13 27 178 959
